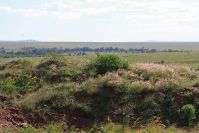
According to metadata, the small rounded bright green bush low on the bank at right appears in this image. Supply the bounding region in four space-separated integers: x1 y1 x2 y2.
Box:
180 104 196 127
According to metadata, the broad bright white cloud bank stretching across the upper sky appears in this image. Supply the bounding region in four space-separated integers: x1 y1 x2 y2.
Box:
0 0 199 25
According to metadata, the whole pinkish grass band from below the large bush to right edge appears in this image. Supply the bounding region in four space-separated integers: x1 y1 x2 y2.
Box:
83 63 199 91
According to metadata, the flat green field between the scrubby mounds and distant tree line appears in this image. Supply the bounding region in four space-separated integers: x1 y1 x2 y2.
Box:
0 52 199 69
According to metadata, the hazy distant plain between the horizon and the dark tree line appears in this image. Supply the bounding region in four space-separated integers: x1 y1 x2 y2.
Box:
0 41 199 51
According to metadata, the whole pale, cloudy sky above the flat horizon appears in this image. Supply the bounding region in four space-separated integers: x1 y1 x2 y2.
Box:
0 0 199 42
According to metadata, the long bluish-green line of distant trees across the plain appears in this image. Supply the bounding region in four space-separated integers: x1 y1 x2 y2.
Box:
0 47 185 58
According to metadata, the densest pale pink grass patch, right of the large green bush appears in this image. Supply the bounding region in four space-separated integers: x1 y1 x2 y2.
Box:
131 63 199 83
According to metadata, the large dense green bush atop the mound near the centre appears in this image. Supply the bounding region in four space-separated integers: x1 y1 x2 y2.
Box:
89 55 129 74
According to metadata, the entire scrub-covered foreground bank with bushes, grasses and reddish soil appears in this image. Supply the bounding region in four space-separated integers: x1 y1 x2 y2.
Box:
0 54 199 133
